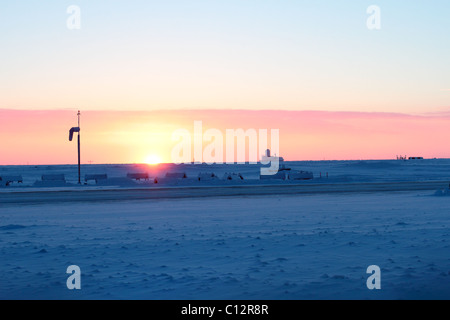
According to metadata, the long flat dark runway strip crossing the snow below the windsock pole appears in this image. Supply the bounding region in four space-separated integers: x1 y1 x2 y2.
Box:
0 181 448 206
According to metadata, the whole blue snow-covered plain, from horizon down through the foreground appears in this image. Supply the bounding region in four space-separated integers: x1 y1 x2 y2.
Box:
0 160 450 299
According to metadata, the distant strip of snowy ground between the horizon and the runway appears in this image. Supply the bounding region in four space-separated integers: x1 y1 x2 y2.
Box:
0 159 450 188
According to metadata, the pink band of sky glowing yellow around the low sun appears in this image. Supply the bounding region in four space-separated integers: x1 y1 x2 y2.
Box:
0 109 450 165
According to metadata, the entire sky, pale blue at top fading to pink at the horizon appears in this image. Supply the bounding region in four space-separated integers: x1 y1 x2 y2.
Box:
0 0 450 164
